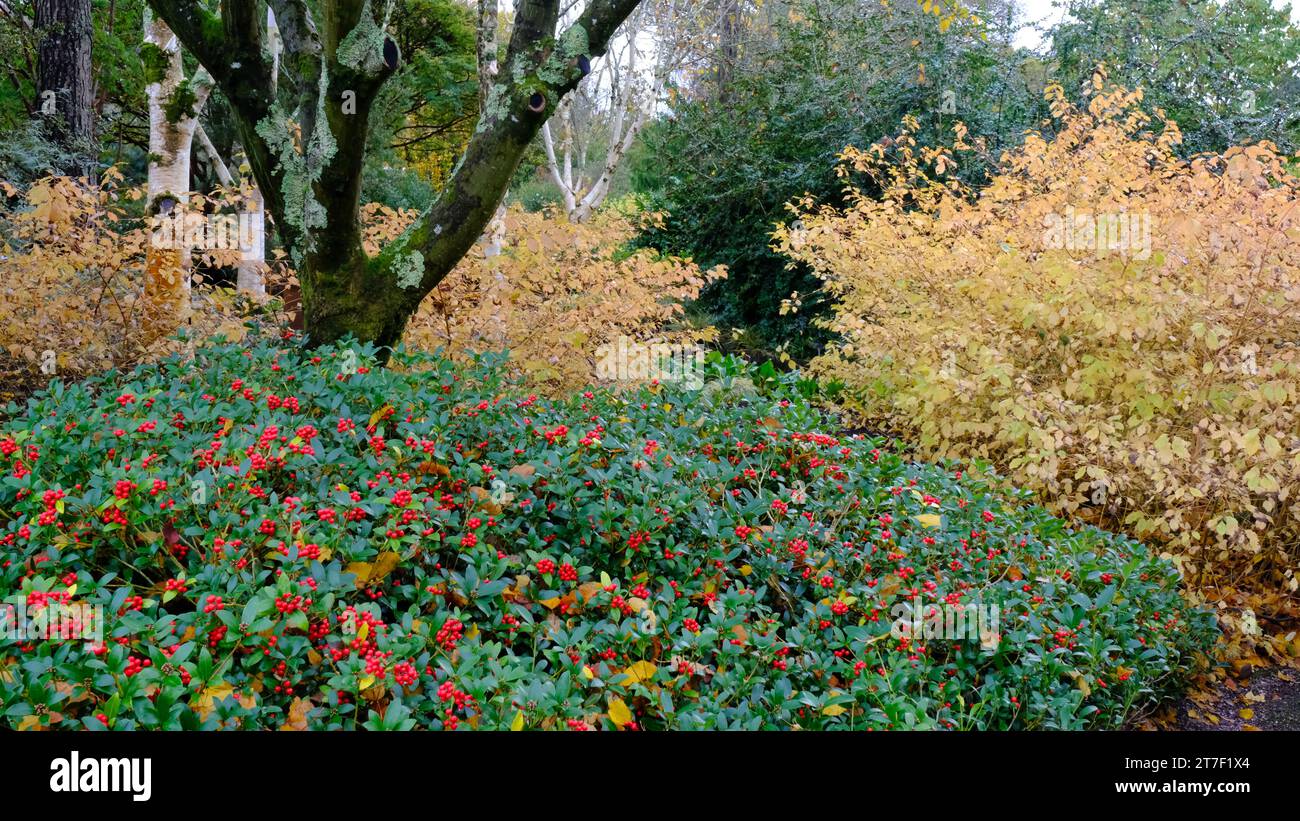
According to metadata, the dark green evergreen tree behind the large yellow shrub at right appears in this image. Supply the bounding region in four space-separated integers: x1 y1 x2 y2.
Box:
632 0 1047 359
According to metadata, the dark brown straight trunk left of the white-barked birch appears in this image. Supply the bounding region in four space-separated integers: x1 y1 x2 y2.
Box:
34 0 99 177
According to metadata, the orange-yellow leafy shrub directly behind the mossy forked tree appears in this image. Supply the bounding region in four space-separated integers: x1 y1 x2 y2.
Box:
364 204 725 388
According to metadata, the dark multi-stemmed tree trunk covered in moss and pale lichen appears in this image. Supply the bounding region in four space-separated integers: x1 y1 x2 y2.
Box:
150 0 640 355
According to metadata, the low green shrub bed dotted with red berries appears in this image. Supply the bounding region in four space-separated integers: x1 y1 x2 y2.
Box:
0 329 1216 730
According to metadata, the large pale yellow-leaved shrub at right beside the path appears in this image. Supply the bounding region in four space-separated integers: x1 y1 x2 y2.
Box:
775 71 1300 592
